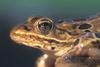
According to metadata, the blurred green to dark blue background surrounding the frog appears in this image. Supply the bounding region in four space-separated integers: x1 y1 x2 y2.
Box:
0 0 100 67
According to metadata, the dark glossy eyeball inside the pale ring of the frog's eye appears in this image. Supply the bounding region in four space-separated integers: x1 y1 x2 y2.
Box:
38 22 52 34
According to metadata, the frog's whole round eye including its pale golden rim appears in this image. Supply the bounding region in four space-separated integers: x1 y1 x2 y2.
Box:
37 18 53 34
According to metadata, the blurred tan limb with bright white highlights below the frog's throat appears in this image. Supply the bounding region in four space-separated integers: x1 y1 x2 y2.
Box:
36 53 56 67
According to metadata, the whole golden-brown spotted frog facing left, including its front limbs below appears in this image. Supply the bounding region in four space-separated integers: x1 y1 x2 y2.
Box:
10 16 100 67
